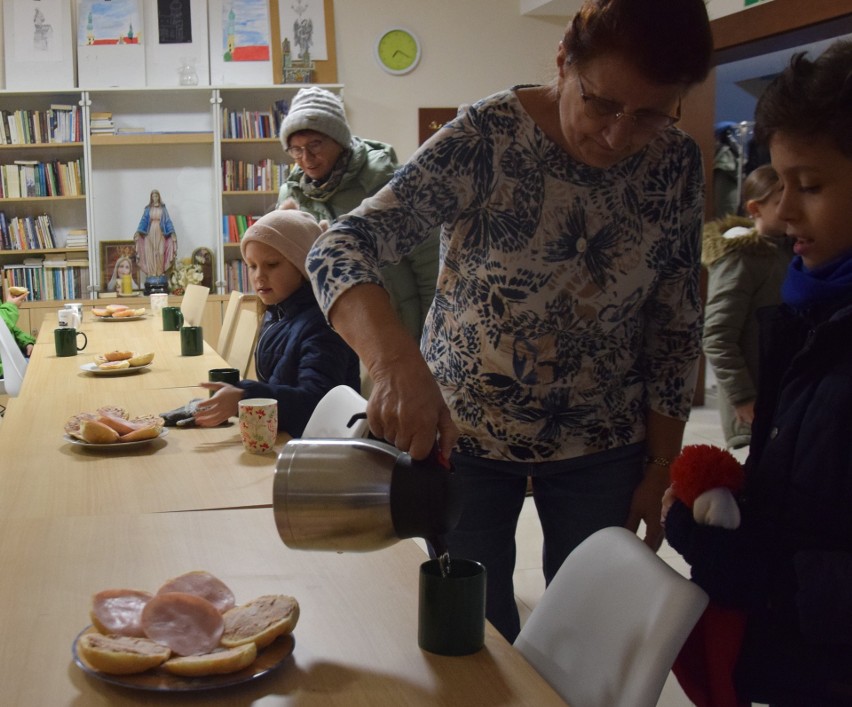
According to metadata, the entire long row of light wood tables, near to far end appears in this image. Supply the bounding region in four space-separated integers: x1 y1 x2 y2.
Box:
0 308 564 707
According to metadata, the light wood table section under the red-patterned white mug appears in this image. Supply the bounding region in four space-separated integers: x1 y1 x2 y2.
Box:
0 388 287 517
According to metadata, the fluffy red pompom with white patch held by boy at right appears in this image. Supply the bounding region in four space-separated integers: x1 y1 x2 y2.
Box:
670 444 743 529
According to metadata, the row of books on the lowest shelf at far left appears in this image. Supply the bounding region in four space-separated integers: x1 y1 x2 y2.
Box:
2 255 91 301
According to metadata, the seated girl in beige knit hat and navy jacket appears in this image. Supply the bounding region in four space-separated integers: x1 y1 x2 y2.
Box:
195 210 360 437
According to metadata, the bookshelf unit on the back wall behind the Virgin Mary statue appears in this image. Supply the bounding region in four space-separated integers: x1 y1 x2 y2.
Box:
0 84 342 308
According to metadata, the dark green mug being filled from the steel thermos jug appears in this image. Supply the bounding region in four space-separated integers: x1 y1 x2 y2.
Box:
417 558 486 655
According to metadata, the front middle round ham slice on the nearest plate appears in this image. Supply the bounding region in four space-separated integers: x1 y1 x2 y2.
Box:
142 592 225 655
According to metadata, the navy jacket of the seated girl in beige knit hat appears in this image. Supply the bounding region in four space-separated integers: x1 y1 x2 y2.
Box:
239 282 361 437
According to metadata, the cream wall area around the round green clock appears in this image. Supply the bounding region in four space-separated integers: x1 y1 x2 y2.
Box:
334 0 567 160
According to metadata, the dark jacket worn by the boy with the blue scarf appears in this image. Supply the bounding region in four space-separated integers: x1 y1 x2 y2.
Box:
666 290 852 705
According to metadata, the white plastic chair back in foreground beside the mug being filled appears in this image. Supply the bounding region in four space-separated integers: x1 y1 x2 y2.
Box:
515 527 708 707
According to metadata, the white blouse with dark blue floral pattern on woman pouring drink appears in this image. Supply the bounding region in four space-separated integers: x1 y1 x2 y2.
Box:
308 90 704 462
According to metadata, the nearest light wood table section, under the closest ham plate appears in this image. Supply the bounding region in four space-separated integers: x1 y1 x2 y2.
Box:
0 509 564 707
